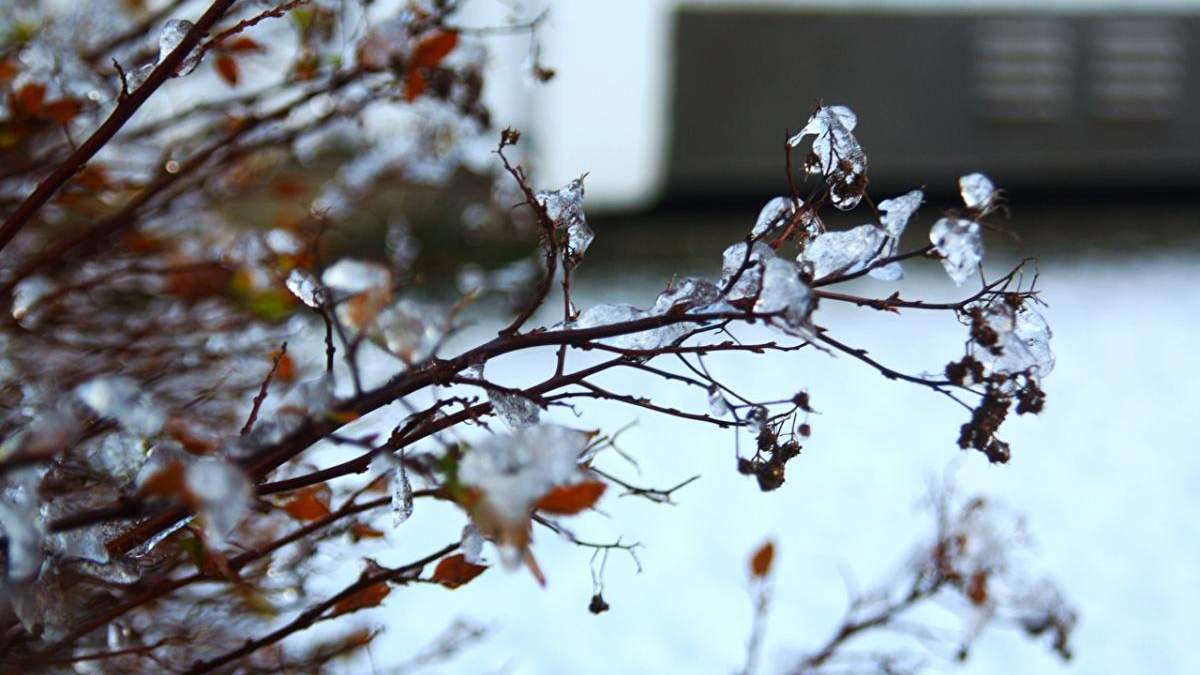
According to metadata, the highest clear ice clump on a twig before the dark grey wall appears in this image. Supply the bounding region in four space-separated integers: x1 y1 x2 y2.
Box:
787 106 866 211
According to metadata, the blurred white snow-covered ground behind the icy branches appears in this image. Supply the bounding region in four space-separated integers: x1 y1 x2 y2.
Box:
290 242 1200 674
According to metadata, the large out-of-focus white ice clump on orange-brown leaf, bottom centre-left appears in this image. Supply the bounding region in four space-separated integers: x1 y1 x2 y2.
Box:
458 424 592 566
